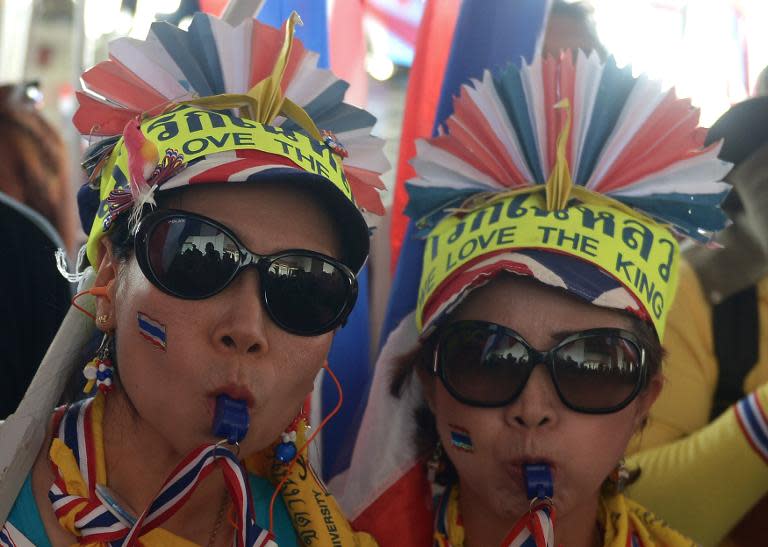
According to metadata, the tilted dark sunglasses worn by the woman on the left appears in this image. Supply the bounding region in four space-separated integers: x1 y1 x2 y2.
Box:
134 209 357 336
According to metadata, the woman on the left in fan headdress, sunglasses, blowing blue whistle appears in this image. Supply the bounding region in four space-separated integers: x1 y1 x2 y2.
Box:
0 14 382 547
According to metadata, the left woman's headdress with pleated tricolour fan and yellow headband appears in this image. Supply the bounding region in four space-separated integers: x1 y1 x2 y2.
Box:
73 13 389 270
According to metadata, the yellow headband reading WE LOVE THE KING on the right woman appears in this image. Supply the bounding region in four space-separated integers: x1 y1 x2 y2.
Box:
416 192 680 337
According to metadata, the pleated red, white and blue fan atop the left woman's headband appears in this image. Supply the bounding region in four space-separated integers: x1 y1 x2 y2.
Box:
73 13 389 214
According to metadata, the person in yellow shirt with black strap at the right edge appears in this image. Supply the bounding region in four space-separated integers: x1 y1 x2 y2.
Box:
630 97 768 546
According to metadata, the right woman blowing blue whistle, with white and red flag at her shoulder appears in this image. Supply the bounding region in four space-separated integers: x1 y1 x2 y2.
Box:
332 52 729 547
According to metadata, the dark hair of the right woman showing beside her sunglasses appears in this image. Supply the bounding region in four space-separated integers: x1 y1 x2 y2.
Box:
389 308 664 486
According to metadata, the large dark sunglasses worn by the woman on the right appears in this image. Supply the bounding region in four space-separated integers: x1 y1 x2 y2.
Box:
433 321 646 414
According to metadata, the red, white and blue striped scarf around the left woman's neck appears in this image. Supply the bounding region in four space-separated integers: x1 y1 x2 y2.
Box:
48 393 277 547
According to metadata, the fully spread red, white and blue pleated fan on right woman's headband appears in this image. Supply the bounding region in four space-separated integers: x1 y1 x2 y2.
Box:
406 52 731 242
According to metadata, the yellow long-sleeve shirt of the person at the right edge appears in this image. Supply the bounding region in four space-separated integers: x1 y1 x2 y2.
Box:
628 263 768 547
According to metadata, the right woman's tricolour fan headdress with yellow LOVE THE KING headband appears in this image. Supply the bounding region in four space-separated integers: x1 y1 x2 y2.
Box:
406 52 730 337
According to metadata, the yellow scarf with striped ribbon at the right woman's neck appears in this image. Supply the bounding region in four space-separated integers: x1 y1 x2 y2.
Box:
434 486 696 547
